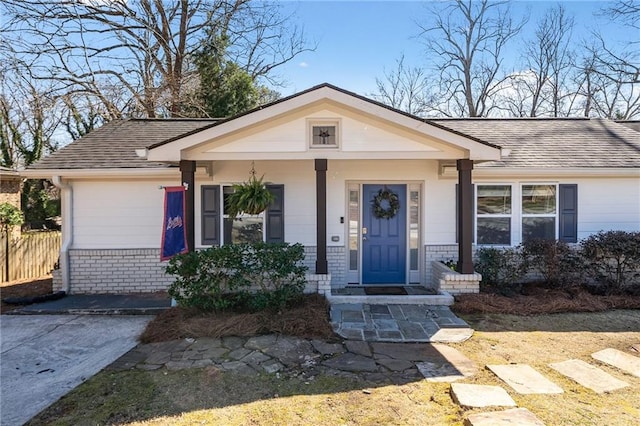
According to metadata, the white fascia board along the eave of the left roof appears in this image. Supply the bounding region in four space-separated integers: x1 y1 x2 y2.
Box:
20 167 180 179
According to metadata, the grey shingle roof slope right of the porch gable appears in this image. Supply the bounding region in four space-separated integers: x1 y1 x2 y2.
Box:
429 118 640 168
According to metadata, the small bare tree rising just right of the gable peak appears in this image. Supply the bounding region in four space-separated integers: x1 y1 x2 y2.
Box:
370 55 433 115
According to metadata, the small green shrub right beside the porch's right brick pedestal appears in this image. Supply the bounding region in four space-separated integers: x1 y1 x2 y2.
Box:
474 247 526 295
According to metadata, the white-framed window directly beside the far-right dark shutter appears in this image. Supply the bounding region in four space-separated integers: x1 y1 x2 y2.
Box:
522 185 557 242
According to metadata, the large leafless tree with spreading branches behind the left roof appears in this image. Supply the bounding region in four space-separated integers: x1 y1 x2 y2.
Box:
0 0 307 120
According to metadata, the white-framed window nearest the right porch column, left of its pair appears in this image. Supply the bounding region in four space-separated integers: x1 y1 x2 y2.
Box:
476 185 512 245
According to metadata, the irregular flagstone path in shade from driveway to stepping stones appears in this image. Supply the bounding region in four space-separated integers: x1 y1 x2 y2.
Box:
109 335 473 383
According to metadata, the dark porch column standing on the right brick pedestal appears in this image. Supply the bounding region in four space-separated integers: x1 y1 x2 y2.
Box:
456 160 473 274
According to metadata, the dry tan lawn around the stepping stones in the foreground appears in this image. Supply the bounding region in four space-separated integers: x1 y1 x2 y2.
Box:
29 310 640 425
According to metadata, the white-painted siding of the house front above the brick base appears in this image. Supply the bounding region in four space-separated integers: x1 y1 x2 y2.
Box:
67 164 640 249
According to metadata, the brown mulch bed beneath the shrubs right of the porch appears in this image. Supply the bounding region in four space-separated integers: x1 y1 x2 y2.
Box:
451 287 640 315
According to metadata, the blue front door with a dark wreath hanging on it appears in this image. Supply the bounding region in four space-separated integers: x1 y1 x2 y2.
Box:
362 185 407 284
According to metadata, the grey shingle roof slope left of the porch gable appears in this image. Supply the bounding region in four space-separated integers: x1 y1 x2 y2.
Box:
30 119 216 169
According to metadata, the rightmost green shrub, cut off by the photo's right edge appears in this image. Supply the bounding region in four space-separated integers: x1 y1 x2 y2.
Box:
580 231 640 293
